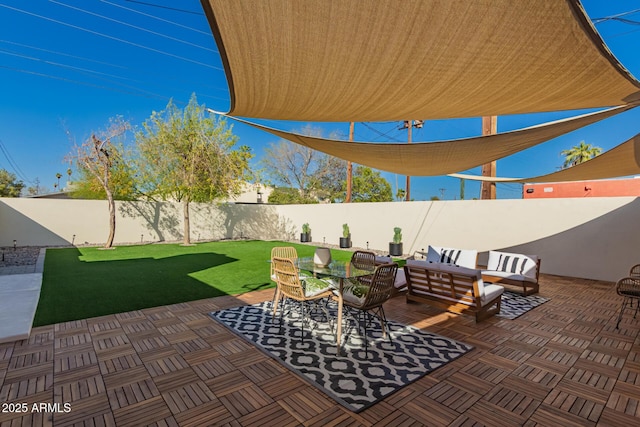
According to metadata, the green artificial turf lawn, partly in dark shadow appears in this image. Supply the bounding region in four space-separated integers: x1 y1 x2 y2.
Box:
33 240 351 326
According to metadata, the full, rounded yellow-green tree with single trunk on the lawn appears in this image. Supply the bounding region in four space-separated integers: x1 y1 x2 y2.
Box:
136 94 252 245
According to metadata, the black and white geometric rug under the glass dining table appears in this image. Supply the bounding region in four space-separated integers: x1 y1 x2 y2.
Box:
210 301 473 412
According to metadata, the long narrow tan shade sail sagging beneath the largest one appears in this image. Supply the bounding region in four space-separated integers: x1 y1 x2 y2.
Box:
220 106 633 176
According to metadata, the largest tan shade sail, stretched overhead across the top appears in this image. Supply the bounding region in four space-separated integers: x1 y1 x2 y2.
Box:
201 0 640 122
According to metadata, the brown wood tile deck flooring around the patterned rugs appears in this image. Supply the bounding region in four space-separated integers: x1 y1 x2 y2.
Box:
0 276 640 427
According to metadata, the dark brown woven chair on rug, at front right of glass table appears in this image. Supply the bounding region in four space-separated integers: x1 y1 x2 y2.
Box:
342 263 398 356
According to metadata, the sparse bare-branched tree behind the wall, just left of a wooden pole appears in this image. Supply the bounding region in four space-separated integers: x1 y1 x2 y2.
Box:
262 125 346 201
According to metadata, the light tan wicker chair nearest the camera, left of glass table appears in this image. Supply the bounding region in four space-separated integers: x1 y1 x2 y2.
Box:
273 257 333 342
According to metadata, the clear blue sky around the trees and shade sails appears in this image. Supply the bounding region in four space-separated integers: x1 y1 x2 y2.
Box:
0 0 640 200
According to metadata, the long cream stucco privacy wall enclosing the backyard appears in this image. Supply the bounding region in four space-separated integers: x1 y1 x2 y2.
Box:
0 197 640 281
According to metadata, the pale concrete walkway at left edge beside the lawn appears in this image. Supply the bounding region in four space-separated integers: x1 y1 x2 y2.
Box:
0 249 46 343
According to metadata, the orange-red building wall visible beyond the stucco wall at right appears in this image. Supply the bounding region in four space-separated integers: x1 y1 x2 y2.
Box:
522 178 640 199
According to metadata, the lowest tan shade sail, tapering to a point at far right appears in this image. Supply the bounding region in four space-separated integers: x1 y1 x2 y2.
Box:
449 134 640 183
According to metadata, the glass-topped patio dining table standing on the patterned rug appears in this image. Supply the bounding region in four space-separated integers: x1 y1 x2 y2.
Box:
295 257 375 354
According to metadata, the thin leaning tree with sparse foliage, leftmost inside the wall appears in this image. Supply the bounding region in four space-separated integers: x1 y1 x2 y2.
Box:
66 117 132 248
